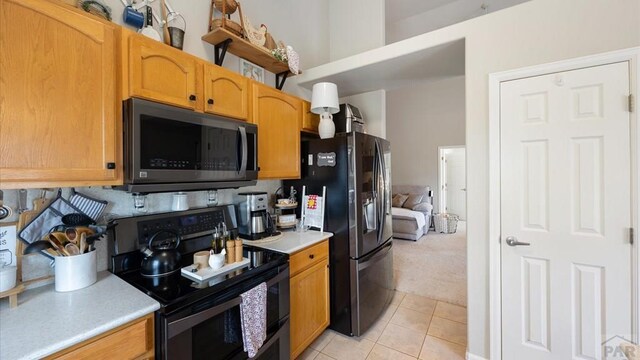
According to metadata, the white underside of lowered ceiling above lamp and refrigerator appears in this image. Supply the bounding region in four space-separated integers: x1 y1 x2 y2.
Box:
298 39 465 97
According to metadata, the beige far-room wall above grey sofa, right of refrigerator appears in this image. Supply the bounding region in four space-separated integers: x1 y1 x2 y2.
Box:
386 76 465 211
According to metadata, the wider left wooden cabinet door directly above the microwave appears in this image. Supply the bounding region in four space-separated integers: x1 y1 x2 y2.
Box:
129 34 202 110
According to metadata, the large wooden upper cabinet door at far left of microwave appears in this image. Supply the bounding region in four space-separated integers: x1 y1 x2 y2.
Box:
0 0 122 188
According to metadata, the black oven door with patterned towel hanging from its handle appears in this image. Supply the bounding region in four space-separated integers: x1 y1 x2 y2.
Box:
156 265 290 360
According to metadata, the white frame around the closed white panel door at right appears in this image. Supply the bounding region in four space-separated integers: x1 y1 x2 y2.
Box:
489 47 640 360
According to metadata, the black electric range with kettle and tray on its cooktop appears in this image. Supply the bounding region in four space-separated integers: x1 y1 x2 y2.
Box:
108 205 289 359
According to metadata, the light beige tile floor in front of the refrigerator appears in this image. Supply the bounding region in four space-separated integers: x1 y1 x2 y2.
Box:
298 292 467 360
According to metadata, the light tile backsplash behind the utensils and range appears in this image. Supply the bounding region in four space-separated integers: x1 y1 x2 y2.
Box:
0 180 282 280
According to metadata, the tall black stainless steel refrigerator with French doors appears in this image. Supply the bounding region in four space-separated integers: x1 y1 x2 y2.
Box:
283 132 393 336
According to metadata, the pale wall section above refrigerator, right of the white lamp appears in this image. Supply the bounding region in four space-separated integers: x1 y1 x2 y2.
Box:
340 90 387 138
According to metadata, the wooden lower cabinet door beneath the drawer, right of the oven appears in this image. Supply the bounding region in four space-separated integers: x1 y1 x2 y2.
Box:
290 258 329 359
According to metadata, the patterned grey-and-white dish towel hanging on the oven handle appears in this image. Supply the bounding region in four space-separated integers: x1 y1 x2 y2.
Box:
240 283 267 358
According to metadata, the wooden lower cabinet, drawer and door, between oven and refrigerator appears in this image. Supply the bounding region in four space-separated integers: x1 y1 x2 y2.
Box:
290 240 329 359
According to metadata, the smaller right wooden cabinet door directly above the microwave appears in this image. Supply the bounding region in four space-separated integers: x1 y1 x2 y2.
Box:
204 65 250 120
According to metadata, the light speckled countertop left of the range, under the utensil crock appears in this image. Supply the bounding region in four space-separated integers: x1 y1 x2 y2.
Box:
0 271 160 360
